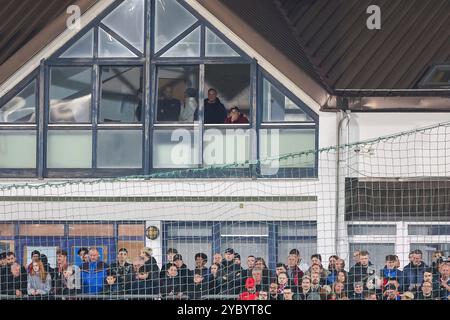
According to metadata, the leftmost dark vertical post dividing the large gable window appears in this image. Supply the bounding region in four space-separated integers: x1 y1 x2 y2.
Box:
36 59 47 180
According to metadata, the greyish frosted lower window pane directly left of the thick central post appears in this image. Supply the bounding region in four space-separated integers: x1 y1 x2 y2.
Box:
97 130 142 168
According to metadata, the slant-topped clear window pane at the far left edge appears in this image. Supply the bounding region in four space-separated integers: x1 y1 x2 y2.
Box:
0 80 36 123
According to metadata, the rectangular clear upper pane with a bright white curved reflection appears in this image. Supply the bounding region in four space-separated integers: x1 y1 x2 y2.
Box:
50 67 92 123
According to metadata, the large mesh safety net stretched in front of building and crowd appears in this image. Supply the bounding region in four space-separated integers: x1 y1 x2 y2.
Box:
0 123 450 300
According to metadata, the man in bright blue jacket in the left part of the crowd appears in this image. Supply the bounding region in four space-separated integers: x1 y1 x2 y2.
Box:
80 247 109 294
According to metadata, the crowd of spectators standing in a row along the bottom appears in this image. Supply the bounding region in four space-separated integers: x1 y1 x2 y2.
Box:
0 248 450 300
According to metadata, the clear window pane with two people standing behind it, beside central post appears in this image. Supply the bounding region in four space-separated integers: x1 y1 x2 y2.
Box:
156 66 199 123
